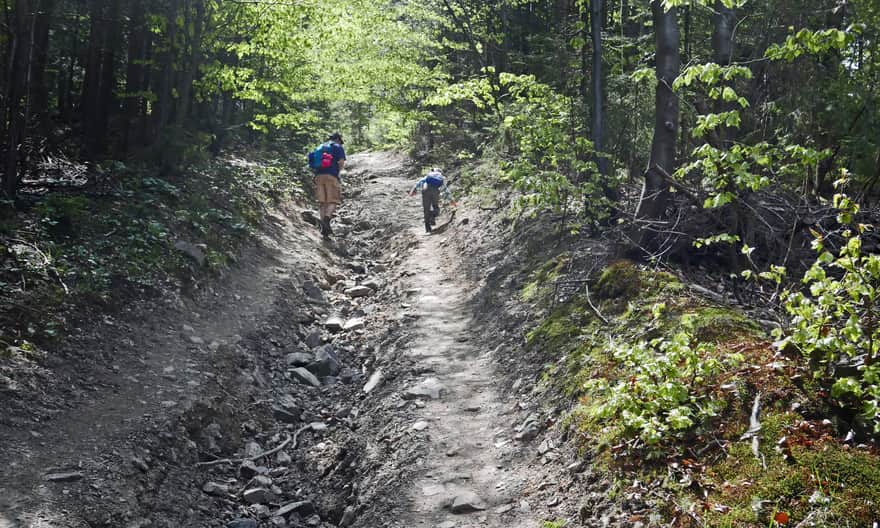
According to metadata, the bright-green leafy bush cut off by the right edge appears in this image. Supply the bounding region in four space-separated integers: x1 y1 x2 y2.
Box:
783 189 880 434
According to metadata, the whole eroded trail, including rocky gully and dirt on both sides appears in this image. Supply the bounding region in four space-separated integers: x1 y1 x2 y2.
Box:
0 153 623 528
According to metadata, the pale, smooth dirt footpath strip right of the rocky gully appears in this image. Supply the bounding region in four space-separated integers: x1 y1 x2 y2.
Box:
360 173 538 528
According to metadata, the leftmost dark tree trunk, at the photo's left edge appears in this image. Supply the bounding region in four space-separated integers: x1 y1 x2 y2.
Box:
3 0 33 196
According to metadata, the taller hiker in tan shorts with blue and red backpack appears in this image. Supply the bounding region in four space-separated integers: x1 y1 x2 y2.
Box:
309 132 345 238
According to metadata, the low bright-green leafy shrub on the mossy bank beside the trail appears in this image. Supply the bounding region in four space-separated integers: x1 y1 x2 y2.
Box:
585 330 742 448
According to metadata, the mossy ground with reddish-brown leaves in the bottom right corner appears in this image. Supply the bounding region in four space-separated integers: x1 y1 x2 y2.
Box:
702 413 880 527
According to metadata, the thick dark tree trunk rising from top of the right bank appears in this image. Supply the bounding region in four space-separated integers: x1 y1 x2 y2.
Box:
636 0 681 228
